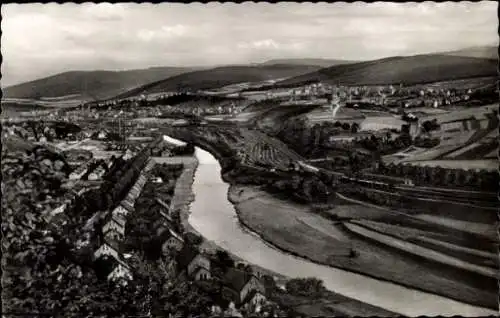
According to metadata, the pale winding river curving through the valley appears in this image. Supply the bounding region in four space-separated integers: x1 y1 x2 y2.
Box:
189 147 498 316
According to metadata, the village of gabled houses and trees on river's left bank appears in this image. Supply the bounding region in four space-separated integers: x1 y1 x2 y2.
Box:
3 120 328 317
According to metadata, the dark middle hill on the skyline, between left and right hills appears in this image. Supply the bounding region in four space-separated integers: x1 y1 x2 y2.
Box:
116 64 321 98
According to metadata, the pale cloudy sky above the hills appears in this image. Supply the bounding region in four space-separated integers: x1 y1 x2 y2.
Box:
1 1 498 87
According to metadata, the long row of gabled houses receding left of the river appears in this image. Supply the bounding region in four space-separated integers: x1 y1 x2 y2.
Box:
94 159 155 284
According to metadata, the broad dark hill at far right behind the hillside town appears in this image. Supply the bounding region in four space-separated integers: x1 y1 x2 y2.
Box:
276 54 497 86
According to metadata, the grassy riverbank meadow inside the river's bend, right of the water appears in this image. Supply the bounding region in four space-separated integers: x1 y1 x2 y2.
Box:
228 185 497 308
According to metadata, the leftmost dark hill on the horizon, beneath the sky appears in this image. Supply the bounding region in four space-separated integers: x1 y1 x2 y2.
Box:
3 67 197 100
